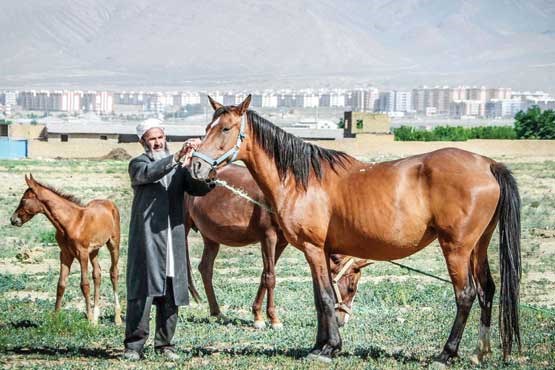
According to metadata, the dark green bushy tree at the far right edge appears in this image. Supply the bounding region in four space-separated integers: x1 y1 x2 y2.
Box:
515 106 555 139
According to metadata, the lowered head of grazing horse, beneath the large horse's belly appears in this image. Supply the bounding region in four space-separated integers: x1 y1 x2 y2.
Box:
330 254 372 326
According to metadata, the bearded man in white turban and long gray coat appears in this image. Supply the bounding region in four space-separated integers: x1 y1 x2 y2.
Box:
124 119 210 360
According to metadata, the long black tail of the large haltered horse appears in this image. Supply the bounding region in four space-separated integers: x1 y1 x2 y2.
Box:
491 163 521 360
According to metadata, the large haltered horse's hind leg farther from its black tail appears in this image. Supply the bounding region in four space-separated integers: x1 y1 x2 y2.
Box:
437 237 476 363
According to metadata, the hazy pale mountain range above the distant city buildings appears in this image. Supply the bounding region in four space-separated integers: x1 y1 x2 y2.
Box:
0 0 555 92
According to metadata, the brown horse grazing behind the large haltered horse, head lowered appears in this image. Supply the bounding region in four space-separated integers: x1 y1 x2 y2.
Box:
185 165 370 329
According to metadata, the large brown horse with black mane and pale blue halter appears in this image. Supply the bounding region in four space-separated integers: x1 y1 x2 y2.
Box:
192 96 521 362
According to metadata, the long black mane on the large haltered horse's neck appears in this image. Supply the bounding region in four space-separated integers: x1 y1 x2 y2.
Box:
247 110 353 190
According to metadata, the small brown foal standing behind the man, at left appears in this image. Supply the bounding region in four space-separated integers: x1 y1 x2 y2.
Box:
11 175 121 325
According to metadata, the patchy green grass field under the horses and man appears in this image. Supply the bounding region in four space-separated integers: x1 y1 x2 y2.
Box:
0 149 555 369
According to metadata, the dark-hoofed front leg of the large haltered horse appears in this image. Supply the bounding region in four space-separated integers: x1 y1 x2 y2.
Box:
304 243 341 362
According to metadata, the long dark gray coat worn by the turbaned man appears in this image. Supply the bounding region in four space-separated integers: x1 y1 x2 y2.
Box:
127 154 210 306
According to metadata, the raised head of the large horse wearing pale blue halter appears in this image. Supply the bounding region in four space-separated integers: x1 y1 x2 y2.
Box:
191 95 251 182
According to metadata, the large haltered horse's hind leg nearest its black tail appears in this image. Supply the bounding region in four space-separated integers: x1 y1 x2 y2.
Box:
471 223 496 364
